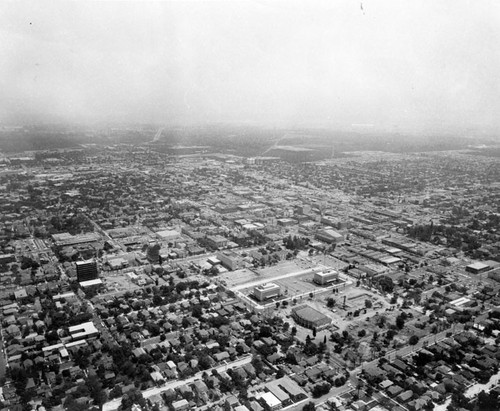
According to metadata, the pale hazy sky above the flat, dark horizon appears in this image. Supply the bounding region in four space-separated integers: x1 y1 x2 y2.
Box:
0 0 500 130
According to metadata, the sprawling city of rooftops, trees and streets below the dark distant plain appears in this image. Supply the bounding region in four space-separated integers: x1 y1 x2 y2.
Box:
0 139 500 411
